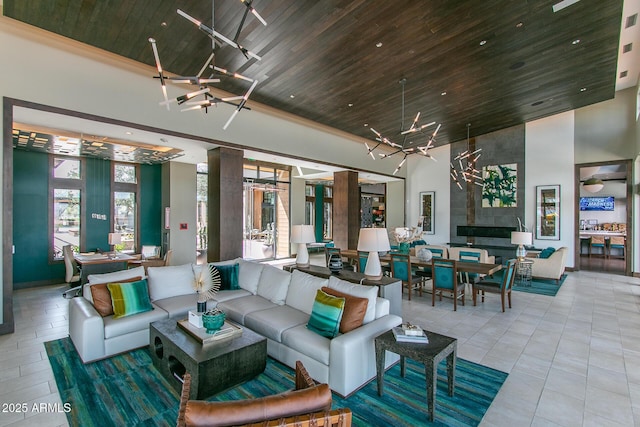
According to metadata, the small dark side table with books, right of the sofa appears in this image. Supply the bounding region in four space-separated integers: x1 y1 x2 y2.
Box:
375 331 458 421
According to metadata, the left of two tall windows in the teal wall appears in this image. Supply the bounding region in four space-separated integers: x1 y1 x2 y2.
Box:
49 156 83 259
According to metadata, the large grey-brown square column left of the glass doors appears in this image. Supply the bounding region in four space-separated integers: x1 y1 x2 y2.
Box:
207 147 244 262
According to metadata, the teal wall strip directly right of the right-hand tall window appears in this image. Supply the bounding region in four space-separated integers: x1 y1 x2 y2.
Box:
139 165 164 246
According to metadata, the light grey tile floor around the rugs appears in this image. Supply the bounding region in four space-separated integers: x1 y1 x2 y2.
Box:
0 262 640 427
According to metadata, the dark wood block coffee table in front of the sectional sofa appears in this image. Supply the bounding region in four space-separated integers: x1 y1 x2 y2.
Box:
149 319 267 400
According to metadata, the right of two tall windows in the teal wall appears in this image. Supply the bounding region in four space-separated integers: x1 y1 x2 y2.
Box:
113 163 139 252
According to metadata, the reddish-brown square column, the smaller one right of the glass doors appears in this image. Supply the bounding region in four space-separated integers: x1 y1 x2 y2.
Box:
333 171 360 249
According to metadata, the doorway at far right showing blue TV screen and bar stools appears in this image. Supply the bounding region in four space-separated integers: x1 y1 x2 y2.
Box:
575 160 633 276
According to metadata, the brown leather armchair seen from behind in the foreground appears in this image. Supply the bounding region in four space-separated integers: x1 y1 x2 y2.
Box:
177 361 351 427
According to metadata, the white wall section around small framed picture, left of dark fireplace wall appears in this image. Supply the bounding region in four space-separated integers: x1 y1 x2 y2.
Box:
406 145 451 244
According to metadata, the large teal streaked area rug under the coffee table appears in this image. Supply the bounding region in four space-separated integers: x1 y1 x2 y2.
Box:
45 338 507 427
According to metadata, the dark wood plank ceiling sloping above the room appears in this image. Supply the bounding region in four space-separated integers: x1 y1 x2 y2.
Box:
4 0 623 146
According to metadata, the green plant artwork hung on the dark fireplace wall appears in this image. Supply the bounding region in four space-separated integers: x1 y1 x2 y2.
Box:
482 163 518 208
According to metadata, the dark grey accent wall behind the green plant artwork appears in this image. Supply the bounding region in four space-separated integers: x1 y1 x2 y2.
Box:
450 125 525 253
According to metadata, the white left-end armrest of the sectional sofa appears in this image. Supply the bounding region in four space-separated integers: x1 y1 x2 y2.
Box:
69 297 105 363
